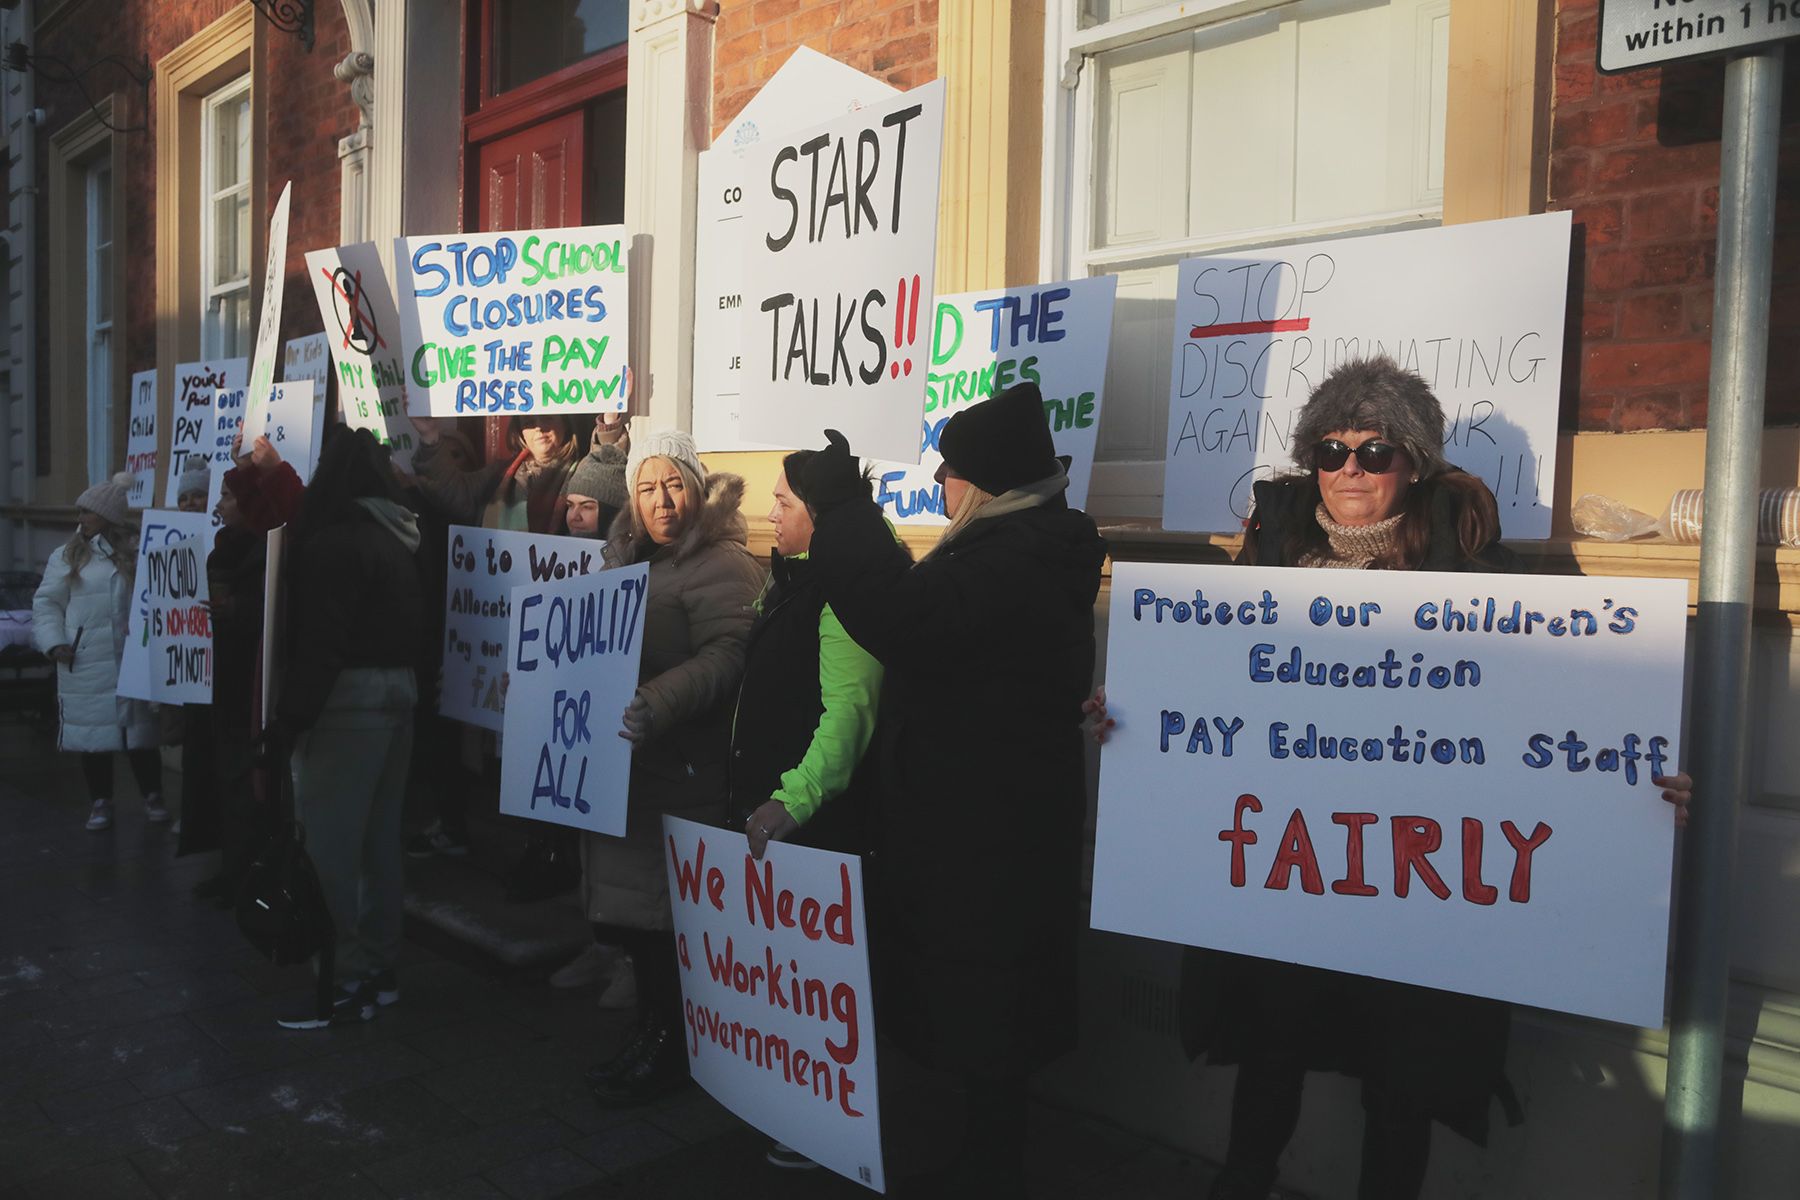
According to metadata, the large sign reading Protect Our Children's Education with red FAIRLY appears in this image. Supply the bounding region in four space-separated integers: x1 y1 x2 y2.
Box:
1093 563 1687 1025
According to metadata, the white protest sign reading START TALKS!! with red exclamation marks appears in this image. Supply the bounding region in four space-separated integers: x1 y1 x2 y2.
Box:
740 81 943 462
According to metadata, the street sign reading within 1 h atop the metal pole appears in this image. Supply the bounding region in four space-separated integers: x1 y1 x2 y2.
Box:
1600 0 1800 74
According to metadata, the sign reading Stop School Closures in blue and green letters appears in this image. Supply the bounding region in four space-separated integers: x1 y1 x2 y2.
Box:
394 225 630 417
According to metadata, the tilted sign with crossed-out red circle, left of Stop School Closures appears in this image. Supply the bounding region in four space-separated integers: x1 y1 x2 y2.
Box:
306 241 423 470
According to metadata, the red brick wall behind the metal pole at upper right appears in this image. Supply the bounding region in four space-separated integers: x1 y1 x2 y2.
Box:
1550 0 1800 432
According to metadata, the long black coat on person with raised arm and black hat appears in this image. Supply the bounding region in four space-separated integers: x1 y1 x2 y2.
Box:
812 495 1105 1076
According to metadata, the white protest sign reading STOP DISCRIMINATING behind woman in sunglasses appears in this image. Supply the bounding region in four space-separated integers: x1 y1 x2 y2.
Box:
1163 212 1570 538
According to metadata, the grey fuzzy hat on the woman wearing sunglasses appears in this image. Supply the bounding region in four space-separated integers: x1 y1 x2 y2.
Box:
1294 358 1449 479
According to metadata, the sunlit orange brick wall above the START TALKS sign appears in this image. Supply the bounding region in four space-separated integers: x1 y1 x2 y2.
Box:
713 0 938 133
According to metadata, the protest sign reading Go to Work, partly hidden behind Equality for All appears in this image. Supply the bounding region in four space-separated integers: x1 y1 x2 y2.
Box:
437 525 601 732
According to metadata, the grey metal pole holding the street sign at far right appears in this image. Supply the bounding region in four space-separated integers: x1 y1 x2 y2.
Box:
1661 45 1782 1200
